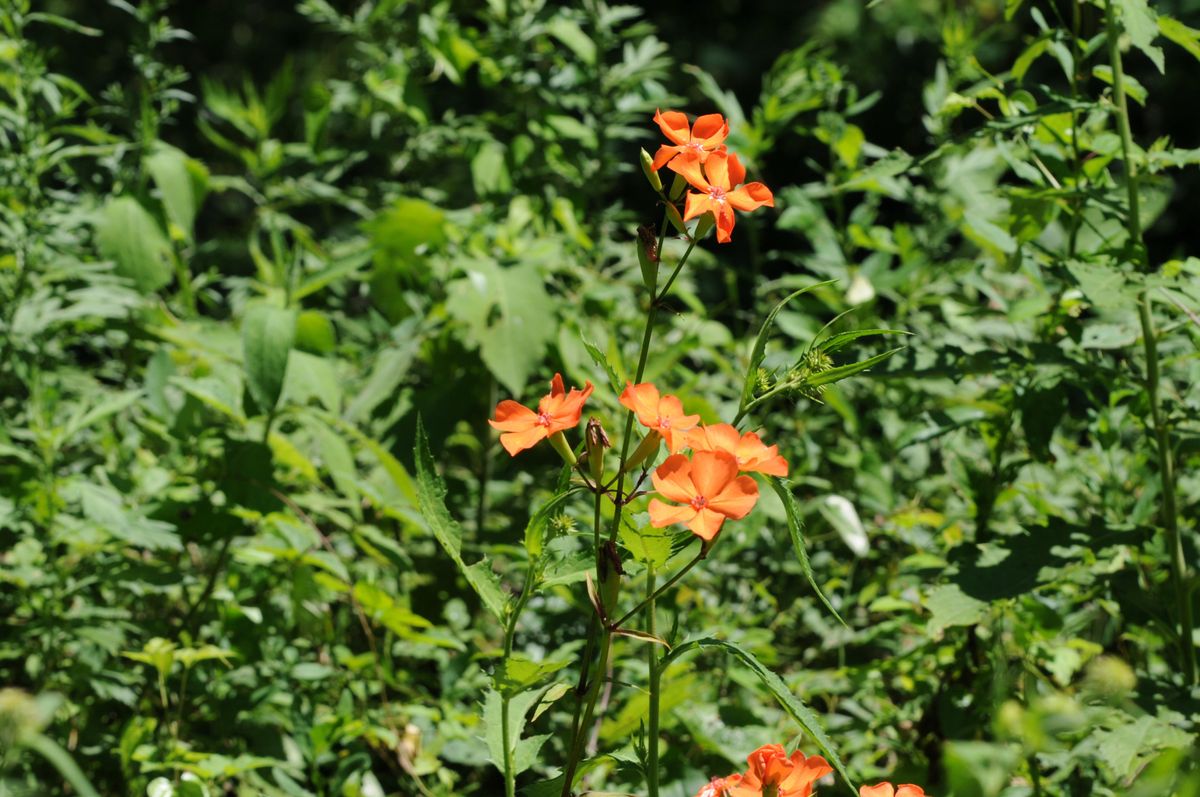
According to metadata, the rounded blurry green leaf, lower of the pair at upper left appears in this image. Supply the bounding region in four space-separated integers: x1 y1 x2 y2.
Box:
95 197 174 293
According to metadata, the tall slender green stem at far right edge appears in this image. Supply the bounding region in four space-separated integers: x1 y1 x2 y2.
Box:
1104 0 1196 684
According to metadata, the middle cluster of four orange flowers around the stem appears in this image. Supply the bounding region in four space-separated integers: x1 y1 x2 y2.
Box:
488 373 787 545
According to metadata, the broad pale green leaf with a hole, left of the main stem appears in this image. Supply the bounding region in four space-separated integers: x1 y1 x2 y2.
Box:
446 260 557 394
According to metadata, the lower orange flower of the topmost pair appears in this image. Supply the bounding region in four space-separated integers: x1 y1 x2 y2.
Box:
670 151 775 244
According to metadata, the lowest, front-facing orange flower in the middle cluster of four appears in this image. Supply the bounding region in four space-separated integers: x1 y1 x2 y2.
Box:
650 451 758 537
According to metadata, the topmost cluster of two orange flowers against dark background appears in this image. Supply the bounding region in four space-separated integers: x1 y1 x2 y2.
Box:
649 110 775 244
